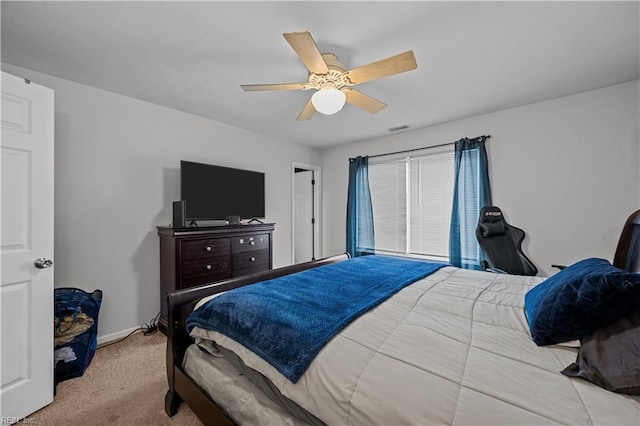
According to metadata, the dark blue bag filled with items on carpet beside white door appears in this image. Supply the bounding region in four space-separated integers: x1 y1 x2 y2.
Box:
53 287 102 385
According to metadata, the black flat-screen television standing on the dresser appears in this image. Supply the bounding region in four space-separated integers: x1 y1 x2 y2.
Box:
180 161 265 220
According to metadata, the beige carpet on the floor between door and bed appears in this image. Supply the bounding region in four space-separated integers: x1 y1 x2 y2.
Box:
28 332 202 426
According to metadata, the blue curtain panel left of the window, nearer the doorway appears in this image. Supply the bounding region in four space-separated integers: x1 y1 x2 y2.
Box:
347 157 375 257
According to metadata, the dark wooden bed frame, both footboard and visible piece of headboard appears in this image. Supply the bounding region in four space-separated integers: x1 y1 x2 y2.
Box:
165 210 640 425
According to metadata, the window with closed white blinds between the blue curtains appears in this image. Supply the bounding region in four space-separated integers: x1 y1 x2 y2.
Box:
369 148 454 260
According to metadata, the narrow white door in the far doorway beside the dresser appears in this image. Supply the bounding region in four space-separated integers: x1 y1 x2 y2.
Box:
293 170 314 263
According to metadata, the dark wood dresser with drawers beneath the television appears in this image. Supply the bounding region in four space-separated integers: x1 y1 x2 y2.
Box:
157 223 275 331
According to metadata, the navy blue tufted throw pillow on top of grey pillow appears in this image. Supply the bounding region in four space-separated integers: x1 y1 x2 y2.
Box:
524 258 640 345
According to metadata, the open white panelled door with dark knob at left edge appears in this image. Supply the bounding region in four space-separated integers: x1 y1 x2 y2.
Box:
0 72 54 423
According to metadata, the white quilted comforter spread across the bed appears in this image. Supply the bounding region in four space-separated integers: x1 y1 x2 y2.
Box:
192 267 640 425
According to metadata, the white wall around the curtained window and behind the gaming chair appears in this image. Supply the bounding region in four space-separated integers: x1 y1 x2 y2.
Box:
322 81 640 275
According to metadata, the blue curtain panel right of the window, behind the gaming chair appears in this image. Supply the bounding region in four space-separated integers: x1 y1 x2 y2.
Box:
449 136 492 270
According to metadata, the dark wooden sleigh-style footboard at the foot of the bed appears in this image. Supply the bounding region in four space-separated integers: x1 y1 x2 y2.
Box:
164 254 349 425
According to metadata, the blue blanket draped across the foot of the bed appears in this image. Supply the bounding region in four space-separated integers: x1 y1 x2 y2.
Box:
187 255 447 383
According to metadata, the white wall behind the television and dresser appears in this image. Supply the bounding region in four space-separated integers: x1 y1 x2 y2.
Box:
2 64 320 340
